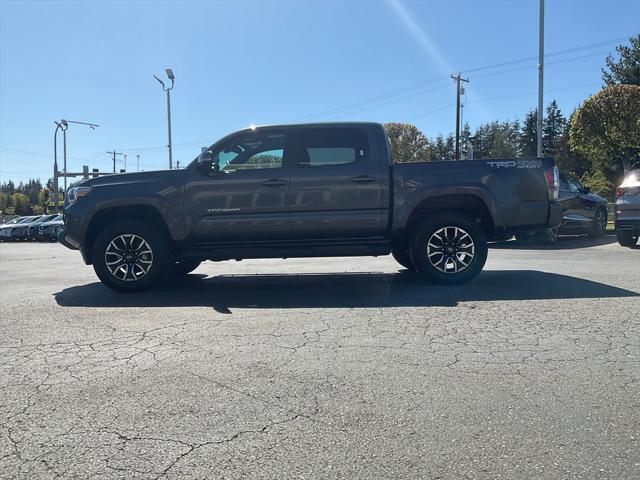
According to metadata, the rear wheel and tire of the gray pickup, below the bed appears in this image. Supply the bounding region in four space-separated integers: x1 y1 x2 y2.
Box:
410 213 488 285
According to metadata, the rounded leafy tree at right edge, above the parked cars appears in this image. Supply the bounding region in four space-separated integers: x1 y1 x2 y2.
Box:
569 85 640 178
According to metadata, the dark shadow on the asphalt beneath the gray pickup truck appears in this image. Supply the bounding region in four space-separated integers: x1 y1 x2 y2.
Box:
54 270 640 313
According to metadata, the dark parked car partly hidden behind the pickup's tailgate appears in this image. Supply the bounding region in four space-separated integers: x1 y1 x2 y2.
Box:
517 172 608 245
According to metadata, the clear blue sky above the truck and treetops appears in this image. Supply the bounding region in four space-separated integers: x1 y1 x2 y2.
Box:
0 0 640 181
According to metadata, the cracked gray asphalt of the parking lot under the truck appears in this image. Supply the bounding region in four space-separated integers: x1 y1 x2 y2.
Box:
0 237 640 479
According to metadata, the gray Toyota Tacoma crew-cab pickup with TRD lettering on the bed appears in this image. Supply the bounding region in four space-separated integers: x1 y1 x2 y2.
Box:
59 123 561 291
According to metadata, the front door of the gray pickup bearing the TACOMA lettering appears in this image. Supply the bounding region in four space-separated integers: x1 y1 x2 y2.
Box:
185 130 291 243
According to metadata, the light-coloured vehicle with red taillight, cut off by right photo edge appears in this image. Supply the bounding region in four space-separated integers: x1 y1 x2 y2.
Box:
615 164 640 247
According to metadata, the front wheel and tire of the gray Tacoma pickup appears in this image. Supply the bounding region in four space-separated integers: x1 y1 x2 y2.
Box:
91 219 170 292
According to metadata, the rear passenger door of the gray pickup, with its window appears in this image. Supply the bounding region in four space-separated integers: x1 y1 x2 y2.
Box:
289 126 385 238
